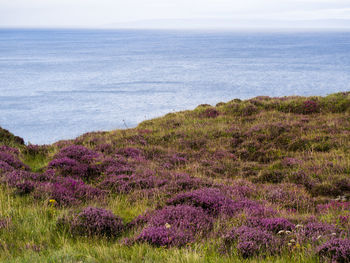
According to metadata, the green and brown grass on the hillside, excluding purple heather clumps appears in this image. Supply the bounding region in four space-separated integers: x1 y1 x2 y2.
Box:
0 93 350 262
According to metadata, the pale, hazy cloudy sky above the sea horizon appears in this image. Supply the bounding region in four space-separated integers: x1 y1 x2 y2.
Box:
0 0 350 29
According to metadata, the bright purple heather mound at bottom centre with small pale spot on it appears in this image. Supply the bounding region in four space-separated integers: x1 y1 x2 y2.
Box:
137 205 213 246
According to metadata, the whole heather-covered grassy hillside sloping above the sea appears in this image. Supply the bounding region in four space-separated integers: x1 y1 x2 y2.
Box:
0 92 350 262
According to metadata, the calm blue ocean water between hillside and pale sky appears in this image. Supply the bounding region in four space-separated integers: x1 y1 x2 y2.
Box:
0 29 350 144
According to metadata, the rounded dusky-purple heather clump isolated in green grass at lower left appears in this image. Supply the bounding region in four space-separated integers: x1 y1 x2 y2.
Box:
58 207 124 238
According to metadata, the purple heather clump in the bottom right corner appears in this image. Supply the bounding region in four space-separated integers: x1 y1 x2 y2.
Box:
317 238 350 263
